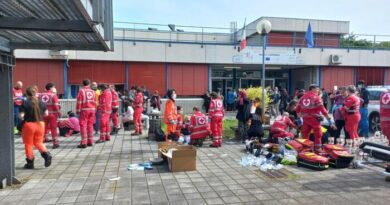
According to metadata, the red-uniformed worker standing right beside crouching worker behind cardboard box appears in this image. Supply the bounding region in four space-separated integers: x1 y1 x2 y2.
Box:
209 92 225 147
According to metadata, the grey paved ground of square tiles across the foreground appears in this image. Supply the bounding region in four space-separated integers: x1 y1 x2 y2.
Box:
0 131 390 205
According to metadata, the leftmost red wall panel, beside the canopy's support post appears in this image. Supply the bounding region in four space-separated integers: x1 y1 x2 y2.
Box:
13 59 64 94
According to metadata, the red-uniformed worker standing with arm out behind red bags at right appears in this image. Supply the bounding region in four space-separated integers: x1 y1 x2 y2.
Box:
296 84 334 153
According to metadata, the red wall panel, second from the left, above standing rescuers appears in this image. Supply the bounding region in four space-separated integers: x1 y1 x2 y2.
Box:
68 60 126 85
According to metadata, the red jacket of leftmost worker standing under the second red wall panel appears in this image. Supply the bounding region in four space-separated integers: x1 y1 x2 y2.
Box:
76 86 96 113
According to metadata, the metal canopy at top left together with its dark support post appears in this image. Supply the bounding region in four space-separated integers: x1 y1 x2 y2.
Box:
0 0 114 188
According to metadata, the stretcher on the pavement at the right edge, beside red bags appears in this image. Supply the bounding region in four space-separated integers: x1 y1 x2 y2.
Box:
353 142 390 180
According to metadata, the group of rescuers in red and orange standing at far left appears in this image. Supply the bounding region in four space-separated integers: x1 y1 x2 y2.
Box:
13 79 152 169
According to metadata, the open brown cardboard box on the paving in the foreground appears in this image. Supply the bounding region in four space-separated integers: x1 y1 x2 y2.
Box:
168 146 196 172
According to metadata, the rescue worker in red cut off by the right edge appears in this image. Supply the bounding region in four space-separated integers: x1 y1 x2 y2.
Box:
379 90 390 146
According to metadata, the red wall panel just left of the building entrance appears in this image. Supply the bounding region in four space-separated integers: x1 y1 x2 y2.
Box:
168 64 208 96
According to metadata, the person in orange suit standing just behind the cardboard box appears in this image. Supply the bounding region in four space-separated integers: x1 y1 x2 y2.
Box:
164 89 177 141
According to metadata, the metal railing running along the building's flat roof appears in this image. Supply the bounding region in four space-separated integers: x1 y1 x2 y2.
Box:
114 21 390 50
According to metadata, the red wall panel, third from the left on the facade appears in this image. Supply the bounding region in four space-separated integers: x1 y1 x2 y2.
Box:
129 63 166 96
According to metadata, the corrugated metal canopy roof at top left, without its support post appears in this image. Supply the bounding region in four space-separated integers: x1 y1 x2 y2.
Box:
0 0 113 51
